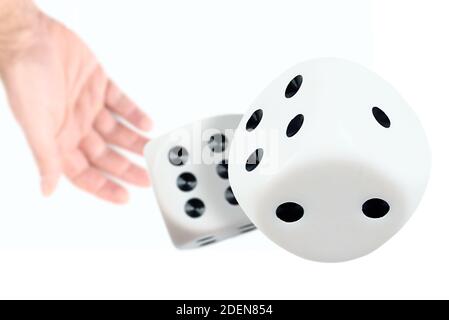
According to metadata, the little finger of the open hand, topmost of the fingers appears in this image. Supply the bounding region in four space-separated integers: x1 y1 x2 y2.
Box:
106 81 152 131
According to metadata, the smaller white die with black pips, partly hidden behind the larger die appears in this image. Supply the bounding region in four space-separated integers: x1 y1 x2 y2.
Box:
145 115 255 248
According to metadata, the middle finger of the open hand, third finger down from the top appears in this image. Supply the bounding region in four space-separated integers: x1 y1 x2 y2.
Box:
80 131 150 187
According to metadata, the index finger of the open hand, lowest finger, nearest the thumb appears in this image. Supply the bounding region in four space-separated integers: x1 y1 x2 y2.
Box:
64 150 128 204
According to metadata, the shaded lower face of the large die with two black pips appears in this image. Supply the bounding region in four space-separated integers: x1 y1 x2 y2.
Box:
243 159 407 262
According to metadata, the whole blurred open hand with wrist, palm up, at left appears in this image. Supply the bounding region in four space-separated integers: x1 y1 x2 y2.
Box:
0 0 152 204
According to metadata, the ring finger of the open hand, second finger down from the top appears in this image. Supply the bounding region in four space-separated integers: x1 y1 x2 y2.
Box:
94 109 149 155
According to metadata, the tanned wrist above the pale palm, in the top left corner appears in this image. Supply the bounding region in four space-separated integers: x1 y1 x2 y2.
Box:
0 0 42 71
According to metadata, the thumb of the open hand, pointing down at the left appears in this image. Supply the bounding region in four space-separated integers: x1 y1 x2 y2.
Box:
25 125 62 196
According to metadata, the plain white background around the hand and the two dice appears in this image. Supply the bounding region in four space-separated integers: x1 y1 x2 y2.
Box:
0 0 449 299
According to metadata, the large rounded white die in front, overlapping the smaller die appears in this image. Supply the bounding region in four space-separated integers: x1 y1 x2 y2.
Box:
229 59 430 262
